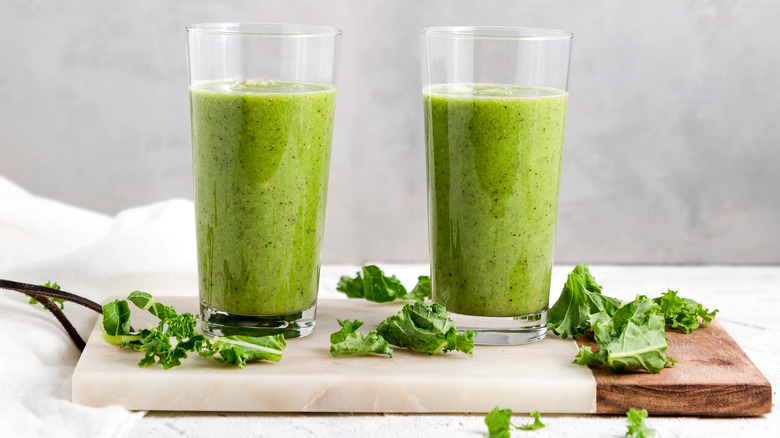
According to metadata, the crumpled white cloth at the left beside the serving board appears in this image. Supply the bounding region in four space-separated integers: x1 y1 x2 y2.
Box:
0 176 197 437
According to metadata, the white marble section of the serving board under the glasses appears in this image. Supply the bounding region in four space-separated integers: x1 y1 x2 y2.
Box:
73 297 596 413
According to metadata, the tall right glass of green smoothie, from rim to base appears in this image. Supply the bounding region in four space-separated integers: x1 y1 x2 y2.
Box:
421 27 572 344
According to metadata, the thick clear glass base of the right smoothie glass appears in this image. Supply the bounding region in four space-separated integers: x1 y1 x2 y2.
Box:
447 309 547 345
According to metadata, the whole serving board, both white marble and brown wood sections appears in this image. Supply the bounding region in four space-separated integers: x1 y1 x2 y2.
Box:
72 297 772 416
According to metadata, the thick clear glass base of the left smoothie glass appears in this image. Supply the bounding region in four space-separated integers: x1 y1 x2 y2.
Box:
200 301 317 339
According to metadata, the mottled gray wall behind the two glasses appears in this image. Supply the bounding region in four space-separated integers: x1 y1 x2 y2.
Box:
0 0 780 263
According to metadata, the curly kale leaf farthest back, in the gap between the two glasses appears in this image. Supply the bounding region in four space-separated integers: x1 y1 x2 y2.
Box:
336 265 431 303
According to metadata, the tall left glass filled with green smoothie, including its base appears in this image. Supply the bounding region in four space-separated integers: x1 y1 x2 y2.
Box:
186 23 341 337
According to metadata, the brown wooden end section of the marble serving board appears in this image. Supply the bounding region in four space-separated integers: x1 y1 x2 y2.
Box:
577 321 772 417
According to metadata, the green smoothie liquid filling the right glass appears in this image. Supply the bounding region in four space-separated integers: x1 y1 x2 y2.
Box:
423 84 568 317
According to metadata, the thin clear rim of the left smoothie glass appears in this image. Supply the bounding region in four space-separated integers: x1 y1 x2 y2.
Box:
184 22 341 38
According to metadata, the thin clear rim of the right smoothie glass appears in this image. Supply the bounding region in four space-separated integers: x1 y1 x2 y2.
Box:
420 26 574 41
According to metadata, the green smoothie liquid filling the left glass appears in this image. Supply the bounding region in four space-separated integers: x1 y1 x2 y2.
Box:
190 79 336 315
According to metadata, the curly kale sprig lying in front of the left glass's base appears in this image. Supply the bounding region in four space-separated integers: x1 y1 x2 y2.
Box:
100 291 286 369
